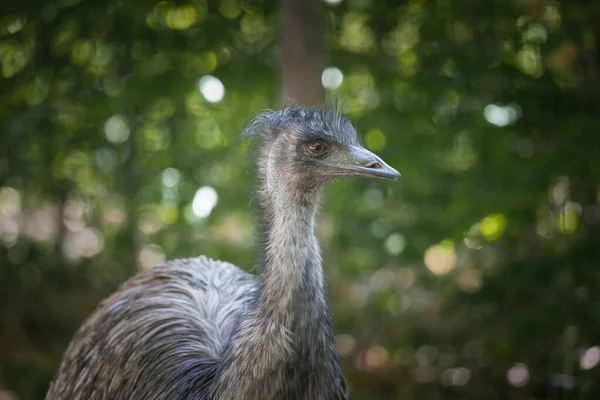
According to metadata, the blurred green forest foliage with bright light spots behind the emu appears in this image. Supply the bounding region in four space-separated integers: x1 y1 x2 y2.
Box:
0 0 600 400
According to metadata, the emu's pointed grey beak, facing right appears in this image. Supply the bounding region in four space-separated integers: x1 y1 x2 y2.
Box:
336 146 400 180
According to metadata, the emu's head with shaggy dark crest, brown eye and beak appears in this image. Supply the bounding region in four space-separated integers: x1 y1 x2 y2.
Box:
245 106 400 193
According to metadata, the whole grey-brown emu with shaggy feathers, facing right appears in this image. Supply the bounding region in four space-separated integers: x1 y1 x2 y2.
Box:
46 106 400 400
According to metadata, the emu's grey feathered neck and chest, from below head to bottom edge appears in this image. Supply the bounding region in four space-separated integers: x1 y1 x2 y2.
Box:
214 142 342 400
